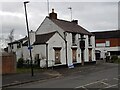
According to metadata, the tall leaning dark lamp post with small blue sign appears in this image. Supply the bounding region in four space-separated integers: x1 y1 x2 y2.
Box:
24 1 34 76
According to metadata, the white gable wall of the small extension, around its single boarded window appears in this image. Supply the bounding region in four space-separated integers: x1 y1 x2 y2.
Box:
47 33 66 67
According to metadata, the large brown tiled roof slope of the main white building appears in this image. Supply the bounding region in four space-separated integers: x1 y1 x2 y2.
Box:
48 17 93 35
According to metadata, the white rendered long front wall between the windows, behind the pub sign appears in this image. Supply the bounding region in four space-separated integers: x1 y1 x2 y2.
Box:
66 33 96 65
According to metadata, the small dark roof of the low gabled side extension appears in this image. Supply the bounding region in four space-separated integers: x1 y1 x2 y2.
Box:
33 31 56 45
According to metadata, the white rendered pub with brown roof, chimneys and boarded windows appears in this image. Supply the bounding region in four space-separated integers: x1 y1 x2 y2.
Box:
7 9 96 67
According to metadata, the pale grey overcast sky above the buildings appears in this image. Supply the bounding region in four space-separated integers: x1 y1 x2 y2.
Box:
0 0 119 48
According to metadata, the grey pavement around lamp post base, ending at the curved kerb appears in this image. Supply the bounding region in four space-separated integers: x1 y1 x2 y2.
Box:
2 70 60 88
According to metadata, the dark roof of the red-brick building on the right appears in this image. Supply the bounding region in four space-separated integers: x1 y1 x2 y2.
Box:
92 30 120 39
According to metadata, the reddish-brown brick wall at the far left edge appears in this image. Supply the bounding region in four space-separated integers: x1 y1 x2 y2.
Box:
1 53 16 74
